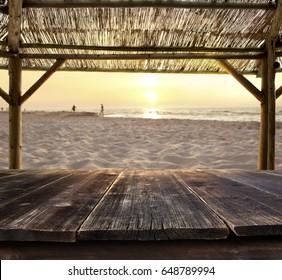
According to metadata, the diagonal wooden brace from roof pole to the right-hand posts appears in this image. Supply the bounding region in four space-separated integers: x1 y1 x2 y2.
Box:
217 59 264 102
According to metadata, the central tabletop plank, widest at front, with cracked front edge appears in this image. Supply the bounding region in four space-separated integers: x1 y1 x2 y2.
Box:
78 167 229 240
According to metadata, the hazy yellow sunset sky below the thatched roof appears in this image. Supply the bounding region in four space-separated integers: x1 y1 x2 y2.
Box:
0 70 282 111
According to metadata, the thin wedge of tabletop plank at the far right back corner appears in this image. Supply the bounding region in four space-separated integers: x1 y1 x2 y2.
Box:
208 169 282 197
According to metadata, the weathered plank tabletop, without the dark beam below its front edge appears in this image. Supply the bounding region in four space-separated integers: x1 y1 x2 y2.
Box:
0 169 282 242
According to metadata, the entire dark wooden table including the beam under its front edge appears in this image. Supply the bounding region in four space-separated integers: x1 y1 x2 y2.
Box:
0 169 282 259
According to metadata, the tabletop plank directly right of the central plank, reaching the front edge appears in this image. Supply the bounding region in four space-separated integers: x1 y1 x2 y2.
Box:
175 171 282 236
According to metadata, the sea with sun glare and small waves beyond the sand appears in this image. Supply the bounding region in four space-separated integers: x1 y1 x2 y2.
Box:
102 107 282 122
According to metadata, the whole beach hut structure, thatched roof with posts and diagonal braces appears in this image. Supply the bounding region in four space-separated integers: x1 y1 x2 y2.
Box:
0 0 282 170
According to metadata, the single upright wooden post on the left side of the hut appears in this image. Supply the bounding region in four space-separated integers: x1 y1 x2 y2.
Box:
8 0 22 169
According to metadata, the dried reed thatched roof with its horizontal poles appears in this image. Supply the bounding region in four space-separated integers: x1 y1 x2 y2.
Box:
0 0 282 74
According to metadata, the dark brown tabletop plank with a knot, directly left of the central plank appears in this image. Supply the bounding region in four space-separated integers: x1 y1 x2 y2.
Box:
0 169 120 242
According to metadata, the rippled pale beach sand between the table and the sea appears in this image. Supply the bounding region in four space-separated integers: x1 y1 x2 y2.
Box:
0 112 282 169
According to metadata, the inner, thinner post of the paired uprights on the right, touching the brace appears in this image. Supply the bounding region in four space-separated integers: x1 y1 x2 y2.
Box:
258 59 268 170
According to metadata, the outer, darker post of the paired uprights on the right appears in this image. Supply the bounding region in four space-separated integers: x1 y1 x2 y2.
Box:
266 40 276 170
